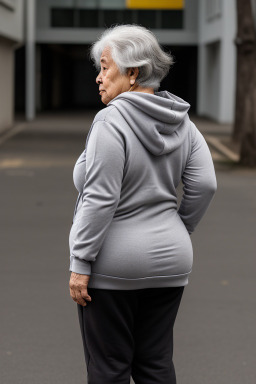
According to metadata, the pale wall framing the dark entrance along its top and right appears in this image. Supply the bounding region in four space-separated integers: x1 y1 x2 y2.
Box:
30 0 236 123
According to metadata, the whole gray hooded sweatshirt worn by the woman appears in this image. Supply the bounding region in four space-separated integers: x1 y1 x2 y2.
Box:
69 91 216 290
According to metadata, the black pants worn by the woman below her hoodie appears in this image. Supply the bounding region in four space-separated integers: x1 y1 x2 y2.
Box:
78 287 184 384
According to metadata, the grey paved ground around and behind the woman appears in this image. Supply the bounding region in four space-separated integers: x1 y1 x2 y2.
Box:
0 111 256 384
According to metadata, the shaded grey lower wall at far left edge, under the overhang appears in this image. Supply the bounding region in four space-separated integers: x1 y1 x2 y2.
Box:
0 37 14 132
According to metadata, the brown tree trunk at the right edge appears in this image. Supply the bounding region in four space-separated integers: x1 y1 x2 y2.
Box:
233 0 256 166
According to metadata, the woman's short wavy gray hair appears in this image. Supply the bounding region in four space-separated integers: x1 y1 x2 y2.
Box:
90 24 173 90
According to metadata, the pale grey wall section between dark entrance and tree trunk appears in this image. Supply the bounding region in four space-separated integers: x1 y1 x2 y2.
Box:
197 0 236 123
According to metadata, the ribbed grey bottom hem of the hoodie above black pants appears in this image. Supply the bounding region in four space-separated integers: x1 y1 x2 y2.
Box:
88 271 191 290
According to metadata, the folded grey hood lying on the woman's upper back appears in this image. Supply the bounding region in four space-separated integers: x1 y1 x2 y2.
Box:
107 91 190 156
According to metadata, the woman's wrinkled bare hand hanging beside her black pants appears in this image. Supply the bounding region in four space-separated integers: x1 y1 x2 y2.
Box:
69 272 92 307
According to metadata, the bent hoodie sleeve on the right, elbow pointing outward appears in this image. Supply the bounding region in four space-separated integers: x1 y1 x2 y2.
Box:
178 123 217 234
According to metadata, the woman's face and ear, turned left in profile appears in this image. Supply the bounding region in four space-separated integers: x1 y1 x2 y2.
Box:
96 47 130 104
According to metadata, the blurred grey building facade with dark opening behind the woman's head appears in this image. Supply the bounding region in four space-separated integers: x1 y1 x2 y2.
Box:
0 0 236 131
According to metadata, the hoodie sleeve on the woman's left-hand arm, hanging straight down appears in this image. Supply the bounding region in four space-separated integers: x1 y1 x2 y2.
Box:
69 121 125 275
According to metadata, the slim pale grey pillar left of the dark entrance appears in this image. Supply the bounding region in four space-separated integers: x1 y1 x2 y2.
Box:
26 0 36 120
